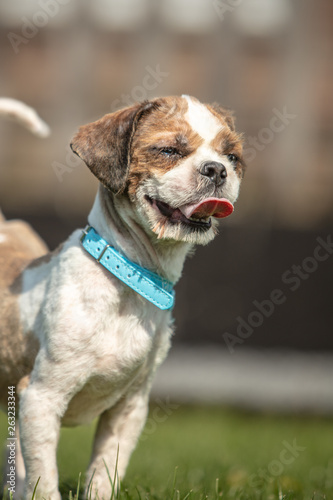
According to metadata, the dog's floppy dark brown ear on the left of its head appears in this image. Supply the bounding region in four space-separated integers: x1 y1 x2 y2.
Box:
70 101 155 194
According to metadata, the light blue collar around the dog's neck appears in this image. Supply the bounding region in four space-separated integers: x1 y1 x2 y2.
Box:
81 226 175 310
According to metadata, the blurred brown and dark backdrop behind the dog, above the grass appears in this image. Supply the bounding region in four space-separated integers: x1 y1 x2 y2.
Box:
0 0 333 411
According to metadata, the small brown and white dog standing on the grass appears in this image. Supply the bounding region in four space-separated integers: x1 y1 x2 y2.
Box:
0 96 244 500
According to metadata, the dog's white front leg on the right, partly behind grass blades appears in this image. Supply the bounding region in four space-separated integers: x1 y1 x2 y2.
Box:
86 391 148 500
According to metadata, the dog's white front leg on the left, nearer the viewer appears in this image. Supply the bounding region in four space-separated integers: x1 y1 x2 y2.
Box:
19 358 79 500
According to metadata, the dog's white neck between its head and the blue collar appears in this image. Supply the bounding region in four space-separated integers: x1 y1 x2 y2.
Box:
88 185 193 283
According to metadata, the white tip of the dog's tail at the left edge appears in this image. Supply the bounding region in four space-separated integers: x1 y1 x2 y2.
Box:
0 98 50 137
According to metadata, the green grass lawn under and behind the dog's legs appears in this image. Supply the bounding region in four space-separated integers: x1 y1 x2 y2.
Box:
0 406 333 500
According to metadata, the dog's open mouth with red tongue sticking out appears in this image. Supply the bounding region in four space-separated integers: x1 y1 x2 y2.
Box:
146 196 234 229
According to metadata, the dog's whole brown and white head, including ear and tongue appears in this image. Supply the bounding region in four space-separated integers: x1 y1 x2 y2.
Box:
71 96 245 244
